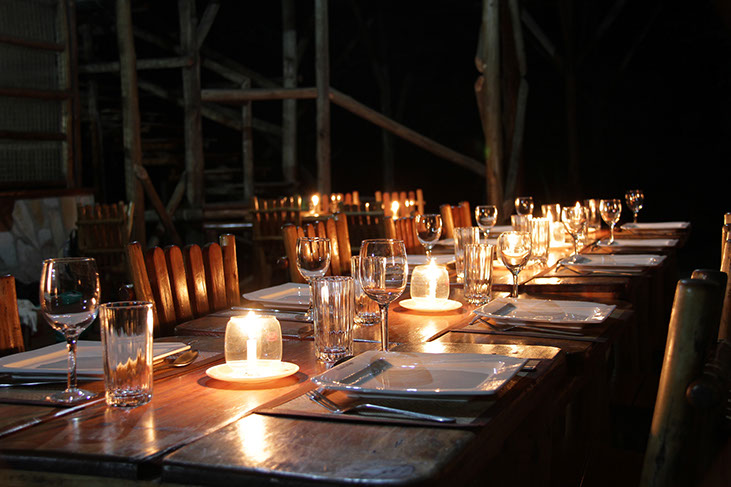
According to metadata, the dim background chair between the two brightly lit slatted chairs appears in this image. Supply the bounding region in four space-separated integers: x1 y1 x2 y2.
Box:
251 196 302 287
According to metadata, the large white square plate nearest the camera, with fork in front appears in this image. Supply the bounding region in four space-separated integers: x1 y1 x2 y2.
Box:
311 350 526 397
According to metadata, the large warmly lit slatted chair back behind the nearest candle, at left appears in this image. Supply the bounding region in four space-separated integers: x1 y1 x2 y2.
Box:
127 235 241 336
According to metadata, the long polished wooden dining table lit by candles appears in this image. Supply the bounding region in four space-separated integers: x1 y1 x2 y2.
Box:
0 224 687 485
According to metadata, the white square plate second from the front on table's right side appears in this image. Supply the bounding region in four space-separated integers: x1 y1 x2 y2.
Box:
474 298 616 324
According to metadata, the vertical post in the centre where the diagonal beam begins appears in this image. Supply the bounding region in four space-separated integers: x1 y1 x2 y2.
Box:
315 0 332 194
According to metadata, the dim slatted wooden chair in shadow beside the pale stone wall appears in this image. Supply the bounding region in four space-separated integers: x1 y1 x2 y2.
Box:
76 202 134 296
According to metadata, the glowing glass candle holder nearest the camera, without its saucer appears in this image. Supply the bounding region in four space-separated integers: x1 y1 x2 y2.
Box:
224 312 282 376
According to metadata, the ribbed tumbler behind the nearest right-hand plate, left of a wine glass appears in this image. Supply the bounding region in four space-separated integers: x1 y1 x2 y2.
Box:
312 276 354 363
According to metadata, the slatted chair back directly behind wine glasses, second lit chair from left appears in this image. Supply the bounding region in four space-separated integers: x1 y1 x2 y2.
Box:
282 214 351 283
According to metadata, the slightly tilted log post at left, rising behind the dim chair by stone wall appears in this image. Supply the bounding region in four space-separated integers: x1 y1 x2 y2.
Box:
116 0 145 242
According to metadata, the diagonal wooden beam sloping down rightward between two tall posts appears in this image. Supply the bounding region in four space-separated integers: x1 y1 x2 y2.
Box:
330 89 485 177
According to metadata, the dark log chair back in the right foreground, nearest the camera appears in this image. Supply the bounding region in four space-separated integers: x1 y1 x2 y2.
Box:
640 279 723 487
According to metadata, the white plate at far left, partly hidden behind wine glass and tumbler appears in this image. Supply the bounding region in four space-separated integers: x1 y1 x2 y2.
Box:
0 340 190 377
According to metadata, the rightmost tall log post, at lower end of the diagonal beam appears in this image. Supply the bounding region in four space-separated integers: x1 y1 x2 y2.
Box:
481 0 503 208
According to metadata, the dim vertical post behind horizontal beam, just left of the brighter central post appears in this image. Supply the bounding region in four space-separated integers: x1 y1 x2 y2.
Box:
282 0 297 183
